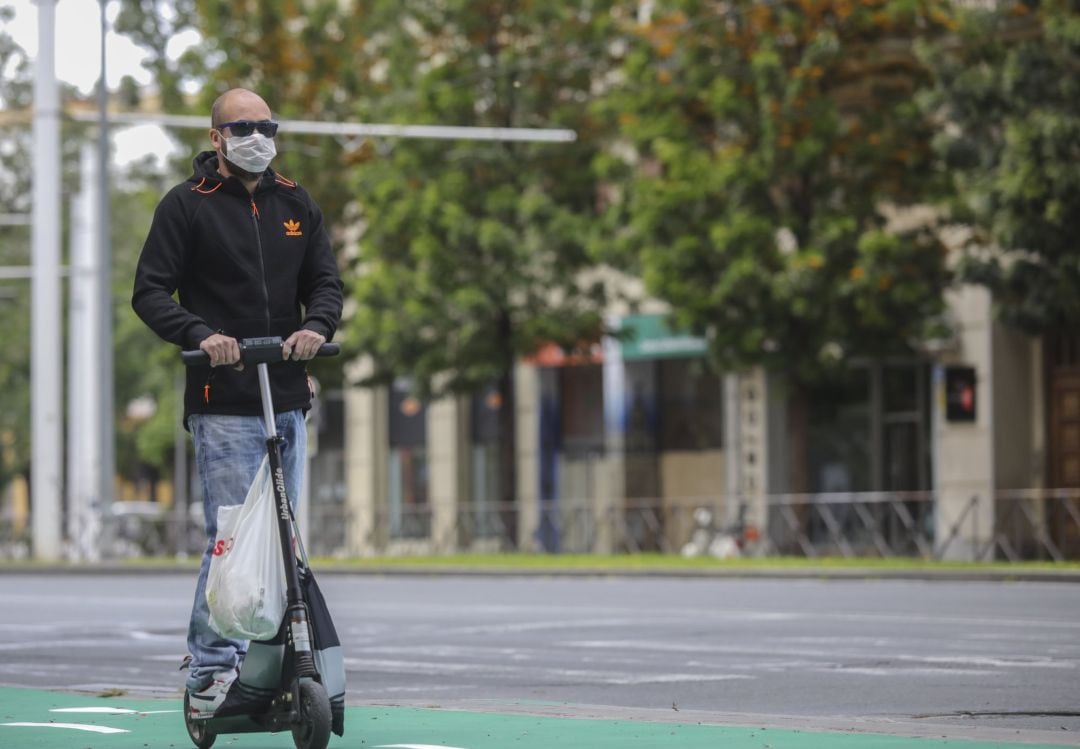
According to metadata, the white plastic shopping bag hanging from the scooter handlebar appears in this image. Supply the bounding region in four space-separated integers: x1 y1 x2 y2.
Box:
206 458 286 640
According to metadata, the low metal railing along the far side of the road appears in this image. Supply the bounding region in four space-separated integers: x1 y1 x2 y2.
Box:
0 489 1080 561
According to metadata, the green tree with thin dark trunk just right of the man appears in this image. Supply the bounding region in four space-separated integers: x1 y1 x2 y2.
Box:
348 0 611 524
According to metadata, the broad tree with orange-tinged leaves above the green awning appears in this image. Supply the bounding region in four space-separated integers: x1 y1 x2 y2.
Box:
598 0 949 382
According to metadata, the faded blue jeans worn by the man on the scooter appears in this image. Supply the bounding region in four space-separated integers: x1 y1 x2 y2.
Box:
187 410 308 691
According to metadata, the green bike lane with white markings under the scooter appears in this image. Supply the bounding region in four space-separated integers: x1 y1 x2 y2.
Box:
0 687 1062 749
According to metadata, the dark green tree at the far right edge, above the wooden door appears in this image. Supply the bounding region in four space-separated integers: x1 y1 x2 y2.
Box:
924 0 1080 335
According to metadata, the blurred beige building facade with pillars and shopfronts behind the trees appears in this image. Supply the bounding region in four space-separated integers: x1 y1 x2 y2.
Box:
326 295 1080 559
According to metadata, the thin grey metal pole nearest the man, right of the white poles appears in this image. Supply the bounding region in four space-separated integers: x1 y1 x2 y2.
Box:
97 0 116 522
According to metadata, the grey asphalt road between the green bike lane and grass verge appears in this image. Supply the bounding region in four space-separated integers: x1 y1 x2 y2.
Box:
0 574 1080 746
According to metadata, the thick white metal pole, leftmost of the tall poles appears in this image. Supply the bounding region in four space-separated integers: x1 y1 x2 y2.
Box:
30 0 63 560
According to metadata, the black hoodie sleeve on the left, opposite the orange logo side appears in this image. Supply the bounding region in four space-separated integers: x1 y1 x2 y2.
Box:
132 190 214 349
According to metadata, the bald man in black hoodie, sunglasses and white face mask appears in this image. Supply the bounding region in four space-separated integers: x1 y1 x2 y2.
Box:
132 88 341 714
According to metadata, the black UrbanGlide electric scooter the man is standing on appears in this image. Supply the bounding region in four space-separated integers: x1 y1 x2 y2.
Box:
180 337 343 749
